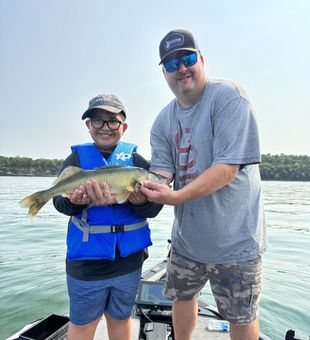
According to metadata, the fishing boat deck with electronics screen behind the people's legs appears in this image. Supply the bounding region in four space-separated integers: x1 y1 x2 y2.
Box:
7 259 297 340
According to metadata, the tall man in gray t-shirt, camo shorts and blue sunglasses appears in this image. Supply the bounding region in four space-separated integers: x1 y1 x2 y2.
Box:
141 29 265 340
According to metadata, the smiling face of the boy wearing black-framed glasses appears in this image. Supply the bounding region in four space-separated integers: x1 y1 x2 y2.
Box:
86 109 128 152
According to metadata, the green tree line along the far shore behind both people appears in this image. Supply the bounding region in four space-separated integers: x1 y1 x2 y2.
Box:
0 154 310 181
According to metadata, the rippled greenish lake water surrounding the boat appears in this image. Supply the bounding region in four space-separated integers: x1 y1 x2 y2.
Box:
0 177 310 340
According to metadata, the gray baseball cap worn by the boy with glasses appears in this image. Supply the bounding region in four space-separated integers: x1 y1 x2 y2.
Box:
82 94 126 119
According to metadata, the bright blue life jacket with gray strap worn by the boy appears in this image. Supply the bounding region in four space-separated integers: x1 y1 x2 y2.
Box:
67 142 152 261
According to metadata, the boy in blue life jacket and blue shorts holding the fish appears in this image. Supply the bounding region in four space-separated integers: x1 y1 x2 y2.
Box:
54 94 162 340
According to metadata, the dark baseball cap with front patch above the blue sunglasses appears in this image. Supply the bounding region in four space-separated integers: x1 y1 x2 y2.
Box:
159 29 199 65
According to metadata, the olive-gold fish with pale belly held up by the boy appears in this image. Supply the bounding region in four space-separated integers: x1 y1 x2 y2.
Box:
19 165 168 217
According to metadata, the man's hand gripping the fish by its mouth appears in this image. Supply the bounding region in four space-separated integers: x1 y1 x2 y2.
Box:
141 181 182 205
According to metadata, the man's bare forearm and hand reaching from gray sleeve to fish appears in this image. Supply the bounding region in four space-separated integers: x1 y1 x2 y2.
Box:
141 164 240 205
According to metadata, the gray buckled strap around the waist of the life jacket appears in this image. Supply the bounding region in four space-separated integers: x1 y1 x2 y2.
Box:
71 212 147 242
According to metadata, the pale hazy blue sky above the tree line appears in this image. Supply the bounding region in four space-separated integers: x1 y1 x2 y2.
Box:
0 0 310 159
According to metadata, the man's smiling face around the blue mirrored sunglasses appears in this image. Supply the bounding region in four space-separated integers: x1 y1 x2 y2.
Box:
163 50 206 105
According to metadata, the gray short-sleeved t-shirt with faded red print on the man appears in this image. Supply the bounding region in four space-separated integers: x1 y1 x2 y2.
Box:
151 79 265 264
